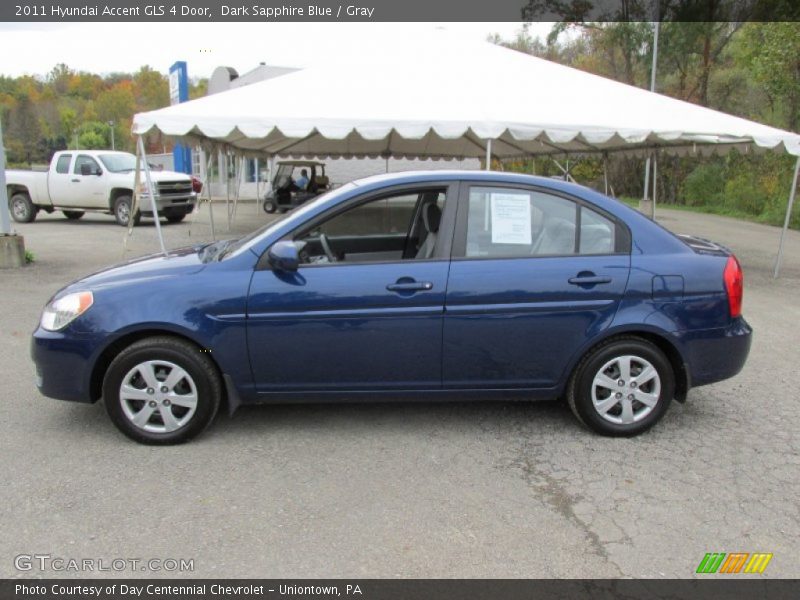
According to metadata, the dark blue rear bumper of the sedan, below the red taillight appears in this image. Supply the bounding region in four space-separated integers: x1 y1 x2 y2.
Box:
675 317 753 387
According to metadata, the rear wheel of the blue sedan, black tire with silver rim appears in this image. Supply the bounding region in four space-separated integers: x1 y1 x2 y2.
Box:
567 337 675 437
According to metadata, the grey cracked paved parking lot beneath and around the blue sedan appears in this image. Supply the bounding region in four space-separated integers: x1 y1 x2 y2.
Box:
0 204 800 578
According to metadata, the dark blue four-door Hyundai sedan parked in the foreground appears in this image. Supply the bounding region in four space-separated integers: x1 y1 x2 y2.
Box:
32 171 752 444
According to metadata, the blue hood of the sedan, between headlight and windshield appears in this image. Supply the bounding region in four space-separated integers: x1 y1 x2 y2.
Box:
64 244 206 291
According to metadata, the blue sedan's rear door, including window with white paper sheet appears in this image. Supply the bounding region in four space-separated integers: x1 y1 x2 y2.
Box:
443 184 630 389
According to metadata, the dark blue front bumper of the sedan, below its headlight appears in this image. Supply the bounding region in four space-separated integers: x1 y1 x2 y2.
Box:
31 327 99 402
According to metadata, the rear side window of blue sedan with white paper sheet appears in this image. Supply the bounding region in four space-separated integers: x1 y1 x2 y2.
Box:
464 186 618 258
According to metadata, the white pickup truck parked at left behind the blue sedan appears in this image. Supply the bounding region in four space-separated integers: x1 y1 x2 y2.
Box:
6 150 199 226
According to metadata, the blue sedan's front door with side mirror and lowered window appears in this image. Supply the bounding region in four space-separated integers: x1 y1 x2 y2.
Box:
247 185 455 393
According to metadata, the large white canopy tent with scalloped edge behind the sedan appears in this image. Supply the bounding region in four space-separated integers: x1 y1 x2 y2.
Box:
133 34 800 274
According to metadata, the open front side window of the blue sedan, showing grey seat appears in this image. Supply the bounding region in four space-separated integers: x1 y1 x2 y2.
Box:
294 189 446 264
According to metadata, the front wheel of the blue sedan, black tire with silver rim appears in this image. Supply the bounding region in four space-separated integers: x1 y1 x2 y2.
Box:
103 336 222 446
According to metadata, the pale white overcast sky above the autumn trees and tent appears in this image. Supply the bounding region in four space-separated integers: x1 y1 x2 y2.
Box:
0 23 550 78
